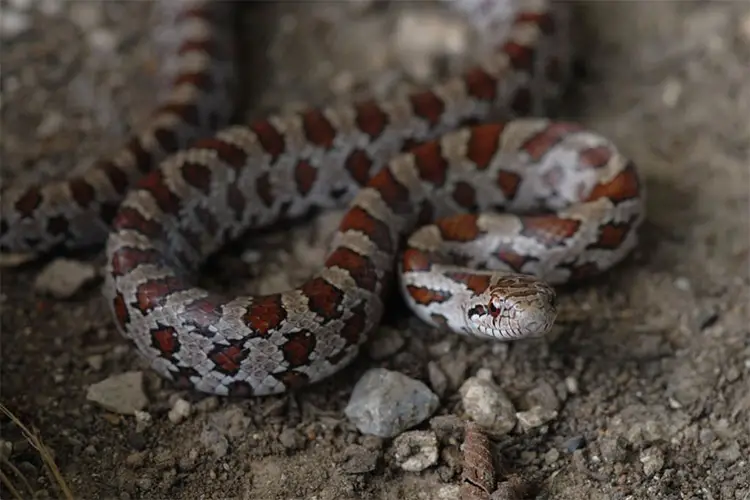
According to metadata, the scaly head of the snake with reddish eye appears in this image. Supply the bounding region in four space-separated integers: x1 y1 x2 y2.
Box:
465 274 557 340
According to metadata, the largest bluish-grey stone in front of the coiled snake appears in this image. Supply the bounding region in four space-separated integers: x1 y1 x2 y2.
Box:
344 368 440 438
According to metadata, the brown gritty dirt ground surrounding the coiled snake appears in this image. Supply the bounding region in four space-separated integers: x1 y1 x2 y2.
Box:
0 0 750 500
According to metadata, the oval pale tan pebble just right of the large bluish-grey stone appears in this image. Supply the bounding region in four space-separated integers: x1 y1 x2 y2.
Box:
459 370 516 435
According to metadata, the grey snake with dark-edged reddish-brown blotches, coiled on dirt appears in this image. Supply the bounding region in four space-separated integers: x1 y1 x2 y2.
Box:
0 0 645 396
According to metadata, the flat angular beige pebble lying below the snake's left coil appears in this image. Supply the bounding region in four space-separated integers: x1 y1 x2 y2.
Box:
86 371 148 415
